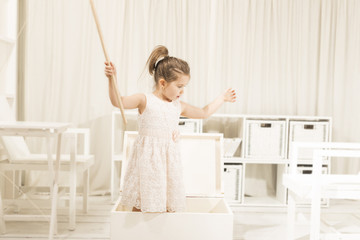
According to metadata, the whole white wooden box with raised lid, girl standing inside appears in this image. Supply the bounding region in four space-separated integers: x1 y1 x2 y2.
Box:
110 132 233 240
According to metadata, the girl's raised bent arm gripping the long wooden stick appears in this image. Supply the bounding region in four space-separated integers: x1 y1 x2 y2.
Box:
105 62 146 113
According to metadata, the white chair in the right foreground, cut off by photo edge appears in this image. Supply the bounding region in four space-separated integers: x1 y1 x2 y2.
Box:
283 142 360 240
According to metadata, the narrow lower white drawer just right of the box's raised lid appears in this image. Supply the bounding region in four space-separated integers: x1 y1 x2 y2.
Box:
224 163 243 203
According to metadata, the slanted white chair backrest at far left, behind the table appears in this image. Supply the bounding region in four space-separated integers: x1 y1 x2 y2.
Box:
0 95 30 161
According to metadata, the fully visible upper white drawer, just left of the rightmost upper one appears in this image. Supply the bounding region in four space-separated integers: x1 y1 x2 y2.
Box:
245 120 286 160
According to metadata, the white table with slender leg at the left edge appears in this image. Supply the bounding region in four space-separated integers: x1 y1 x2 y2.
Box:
0 121 70 239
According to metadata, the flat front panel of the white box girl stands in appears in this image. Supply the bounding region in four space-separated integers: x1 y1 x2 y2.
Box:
110 213 233 240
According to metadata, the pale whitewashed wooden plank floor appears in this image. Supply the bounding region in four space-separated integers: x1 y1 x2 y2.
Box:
0 196 360 240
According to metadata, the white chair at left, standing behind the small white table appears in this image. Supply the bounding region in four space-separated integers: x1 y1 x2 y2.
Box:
0 96 94 233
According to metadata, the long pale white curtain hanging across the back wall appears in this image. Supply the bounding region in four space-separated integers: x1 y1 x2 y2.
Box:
25 0 360 192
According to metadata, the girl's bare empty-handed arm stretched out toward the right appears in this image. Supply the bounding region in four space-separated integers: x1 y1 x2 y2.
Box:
181 88 236 118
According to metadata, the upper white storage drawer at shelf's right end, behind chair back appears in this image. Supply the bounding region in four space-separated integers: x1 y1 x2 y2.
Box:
289 121 329 159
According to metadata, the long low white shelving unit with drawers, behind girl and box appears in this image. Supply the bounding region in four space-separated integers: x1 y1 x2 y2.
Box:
111 111 332 206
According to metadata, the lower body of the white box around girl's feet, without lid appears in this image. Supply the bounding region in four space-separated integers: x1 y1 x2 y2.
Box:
110 198 233 240
